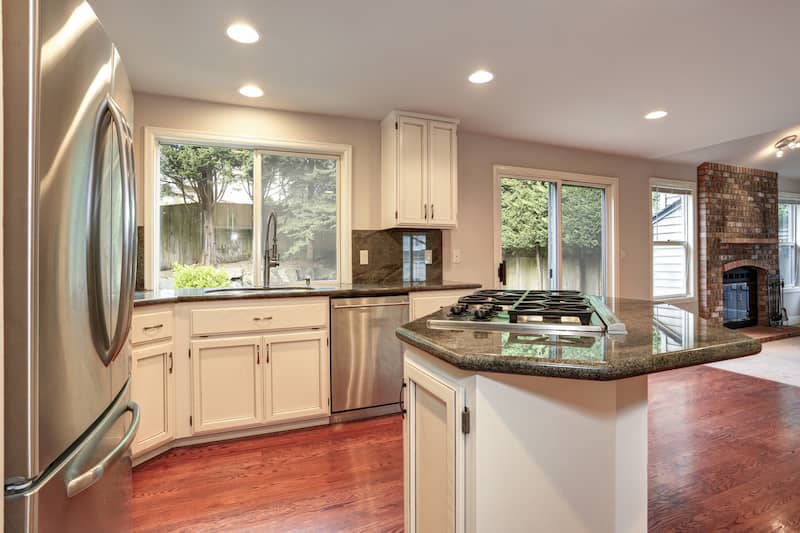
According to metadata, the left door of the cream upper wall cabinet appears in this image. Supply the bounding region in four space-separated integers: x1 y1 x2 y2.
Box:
397 117 428 225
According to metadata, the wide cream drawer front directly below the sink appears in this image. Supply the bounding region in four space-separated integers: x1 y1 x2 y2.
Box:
192 301 328 335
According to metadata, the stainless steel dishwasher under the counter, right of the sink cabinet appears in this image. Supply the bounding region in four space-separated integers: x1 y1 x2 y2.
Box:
331 295 408 421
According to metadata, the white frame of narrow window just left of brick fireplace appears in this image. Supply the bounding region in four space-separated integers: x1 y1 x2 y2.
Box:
647 178 697 303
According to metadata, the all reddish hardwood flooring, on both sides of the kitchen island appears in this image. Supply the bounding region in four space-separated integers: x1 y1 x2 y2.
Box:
134 367 800 532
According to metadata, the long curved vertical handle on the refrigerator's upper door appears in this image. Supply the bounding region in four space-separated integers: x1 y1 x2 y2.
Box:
86 95 136 366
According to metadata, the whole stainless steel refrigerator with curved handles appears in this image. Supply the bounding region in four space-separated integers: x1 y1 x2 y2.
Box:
3 0 139 533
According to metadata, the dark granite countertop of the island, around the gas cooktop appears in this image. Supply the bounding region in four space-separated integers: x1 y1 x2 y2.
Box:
397 299 761 381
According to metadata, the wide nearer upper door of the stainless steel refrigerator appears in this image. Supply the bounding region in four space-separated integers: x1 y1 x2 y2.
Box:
33 0 126 470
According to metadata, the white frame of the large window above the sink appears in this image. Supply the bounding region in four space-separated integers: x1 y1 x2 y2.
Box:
144 127 353 290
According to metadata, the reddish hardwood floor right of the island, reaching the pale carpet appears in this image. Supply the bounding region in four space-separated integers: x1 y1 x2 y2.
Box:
648 367 800 532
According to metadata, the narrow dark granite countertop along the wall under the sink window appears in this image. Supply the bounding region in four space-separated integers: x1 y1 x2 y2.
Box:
133 281 481 307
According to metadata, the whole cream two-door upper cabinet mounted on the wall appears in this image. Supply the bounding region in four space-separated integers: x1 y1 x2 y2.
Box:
381 111 458 228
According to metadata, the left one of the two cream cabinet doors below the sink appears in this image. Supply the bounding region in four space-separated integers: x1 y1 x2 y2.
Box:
192 336 264 434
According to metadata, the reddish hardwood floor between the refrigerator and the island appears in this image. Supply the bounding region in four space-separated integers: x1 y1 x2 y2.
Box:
133 416 403 532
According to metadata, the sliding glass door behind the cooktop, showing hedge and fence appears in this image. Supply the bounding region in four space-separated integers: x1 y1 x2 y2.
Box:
495 170 608 296
